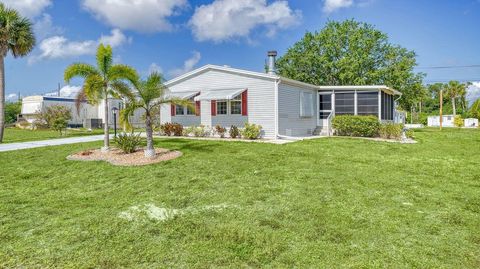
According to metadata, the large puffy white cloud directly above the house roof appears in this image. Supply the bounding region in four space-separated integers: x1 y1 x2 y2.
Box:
189 0 302 42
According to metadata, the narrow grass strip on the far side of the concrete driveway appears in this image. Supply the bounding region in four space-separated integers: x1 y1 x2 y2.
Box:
3 128 103 143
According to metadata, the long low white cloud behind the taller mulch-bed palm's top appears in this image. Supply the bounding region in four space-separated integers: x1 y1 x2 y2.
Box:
29 29 130 63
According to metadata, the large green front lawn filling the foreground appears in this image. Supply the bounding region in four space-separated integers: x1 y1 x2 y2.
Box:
0 129 480 268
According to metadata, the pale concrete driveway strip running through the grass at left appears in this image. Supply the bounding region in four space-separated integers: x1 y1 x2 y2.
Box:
0 135 113 152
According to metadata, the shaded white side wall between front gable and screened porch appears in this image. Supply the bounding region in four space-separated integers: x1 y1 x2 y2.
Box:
278 83 318 136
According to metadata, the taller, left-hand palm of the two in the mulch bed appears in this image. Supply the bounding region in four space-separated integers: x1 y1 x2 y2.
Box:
64 44 138 152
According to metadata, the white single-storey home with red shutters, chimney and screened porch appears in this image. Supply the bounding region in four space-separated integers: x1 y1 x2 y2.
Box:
160 52 401 139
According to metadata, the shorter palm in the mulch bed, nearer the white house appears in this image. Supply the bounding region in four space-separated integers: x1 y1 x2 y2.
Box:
120 72 193 158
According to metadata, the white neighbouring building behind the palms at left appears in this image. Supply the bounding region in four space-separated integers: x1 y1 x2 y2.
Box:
19 95 143 127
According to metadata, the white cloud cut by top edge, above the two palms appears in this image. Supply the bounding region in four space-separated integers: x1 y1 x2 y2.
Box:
82 0 188 32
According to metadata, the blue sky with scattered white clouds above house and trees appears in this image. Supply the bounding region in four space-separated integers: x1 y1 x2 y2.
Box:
0 0 480 101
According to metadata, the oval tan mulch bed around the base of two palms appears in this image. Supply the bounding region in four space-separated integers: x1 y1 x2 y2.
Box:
67 148 182 166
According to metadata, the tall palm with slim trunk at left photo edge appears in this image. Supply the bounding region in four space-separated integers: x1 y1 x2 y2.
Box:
0 3 35 143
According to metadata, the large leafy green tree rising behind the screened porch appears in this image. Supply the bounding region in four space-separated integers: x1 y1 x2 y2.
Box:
277 20 424 111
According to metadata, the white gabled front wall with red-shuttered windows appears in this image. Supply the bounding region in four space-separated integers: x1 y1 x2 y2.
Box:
167 70 275 138
